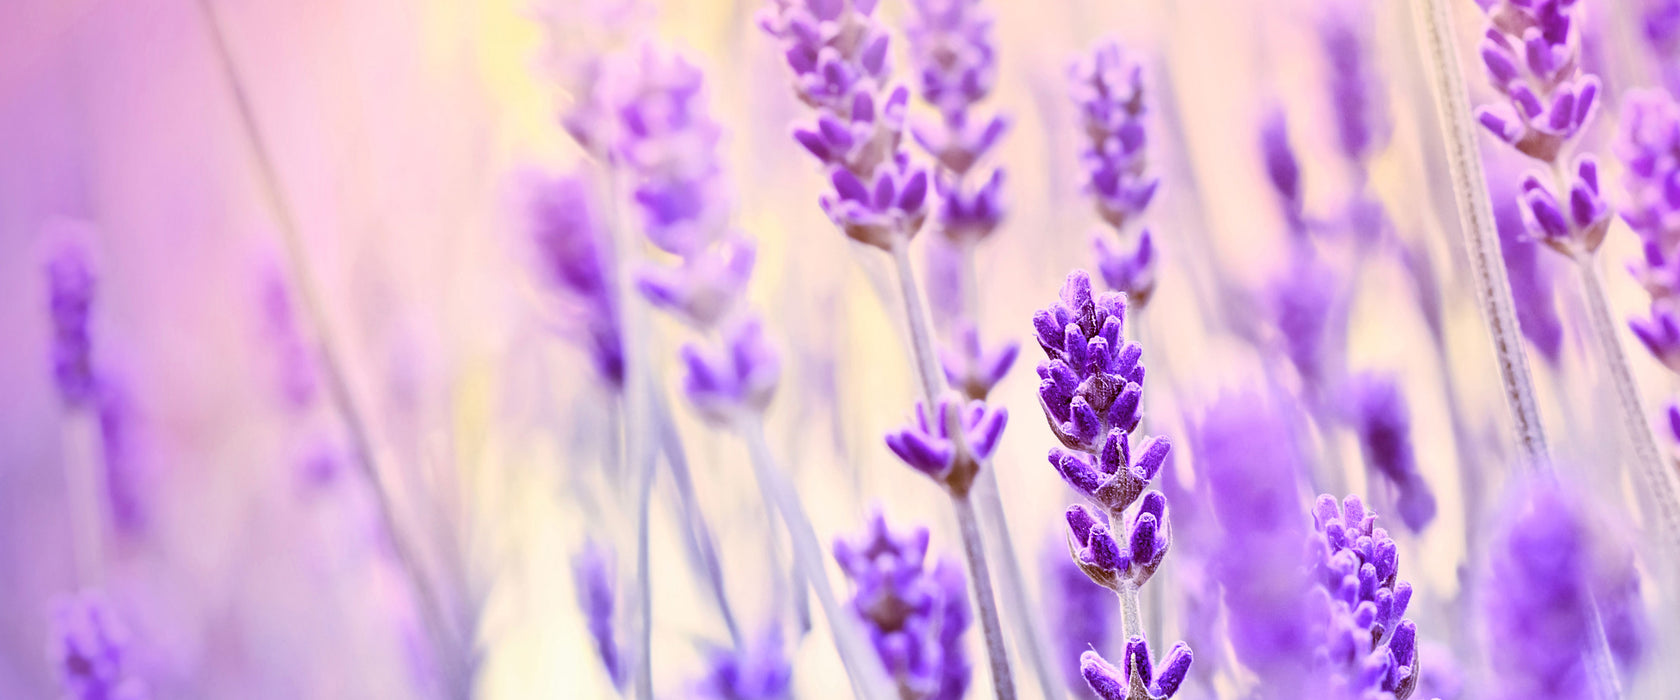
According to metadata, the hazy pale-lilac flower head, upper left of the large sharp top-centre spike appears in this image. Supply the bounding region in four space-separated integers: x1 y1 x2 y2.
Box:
615 47 729 257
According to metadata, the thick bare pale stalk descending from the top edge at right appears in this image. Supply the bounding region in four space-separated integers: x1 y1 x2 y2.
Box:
1411 0 1549 470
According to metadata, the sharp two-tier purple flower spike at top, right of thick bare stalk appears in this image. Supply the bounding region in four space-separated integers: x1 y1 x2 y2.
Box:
1477 0 1609 255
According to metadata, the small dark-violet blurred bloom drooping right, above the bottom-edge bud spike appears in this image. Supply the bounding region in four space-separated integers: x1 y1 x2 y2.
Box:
1347 373 1435 532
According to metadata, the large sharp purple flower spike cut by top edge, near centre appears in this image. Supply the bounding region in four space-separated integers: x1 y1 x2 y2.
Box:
759 0 929 250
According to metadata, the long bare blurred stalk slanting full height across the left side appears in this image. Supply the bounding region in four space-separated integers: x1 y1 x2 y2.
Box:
198 0 470 697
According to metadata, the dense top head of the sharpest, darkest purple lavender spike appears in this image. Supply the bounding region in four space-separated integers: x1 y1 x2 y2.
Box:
1033 270 1144 455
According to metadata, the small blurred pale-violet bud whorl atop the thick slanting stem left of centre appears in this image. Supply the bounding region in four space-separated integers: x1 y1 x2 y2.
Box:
682 314 781 423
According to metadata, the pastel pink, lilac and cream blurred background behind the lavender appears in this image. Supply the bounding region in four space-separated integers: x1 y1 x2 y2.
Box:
0 0 1677 698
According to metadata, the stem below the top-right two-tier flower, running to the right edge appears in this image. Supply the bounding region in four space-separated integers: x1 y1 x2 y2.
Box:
1576 255 1680 547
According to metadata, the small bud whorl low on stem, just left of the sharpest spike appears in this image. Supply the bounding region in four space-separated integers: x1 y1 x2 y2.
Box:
887 396 1010 495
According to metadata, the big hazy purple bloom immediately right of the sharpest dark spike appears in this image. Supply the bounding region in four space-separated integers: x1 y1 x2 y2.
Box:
1196 393 1322 698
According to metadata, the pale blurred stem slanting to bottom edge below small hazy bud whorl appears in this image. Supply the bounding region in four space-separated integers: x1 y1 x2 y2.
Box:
736 416 897 700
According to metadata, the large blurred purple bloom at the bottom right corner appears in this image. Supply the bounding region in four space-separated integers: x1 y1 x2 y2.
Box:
1482 482 1645 698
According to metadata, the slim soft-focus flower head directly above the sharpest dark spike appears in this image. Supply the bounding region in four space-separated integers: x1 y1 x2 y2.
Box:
1070 42 1161 230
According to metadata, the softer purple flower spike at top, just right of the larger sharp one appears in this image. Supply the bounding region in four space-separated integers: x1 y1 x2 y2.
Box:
906 0 1008 243
